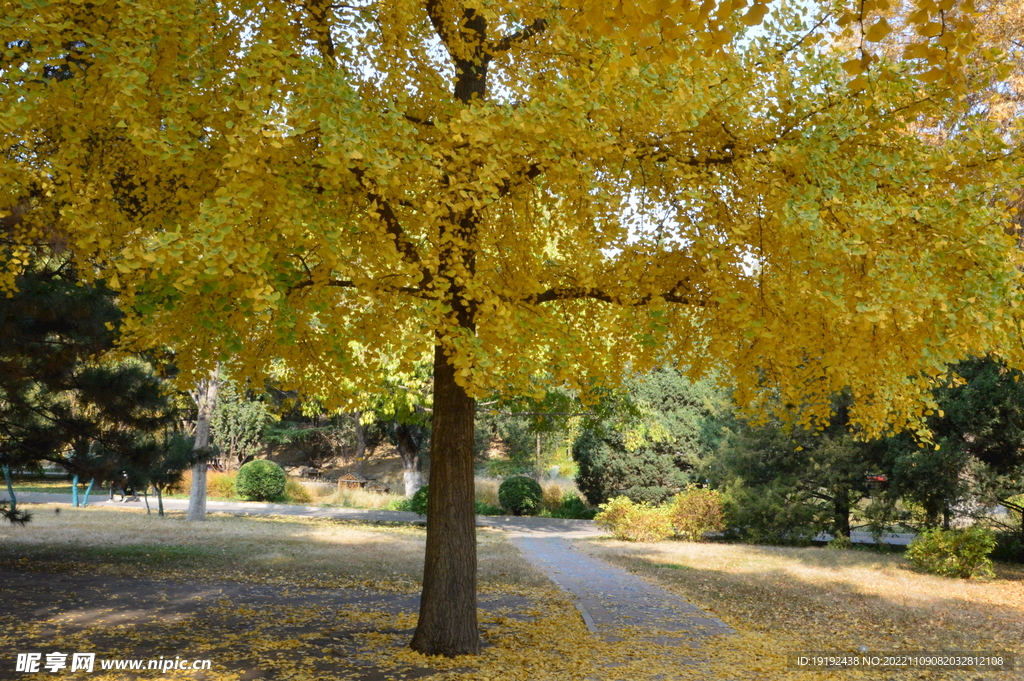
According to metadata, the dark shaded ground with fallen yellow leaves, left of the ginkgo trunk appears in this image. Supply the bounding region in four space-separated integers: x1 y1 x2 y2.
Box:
0 569 530 680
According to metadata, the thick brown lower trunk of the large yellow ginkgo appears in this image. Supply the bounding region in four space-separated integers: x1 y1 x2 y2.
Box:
412 345 480 656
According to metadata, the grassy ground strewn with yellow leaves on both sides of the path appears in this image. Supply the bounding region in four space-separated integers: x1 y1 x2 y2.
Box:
0 507 1024 681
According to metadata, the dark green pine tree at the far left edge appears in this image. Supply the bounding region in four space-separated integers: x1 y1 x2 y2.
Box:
0 256 169 506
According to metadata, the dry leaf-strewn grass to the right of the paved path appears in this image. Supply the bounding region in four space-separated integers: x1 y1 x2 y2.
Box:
582 541 1024 679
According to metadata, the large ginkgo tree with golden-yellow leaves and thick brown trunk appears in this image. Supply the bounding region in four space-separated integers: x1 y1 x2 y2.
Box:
0 0 1020 655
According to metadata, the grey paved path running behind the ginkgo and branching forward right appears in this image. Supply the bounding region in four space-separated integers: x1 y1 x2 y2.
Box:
8 493 731 644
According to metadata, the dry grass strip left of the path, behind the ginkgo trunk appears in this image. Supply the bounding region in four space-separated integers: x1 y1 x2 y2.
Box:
0 505 548 590
